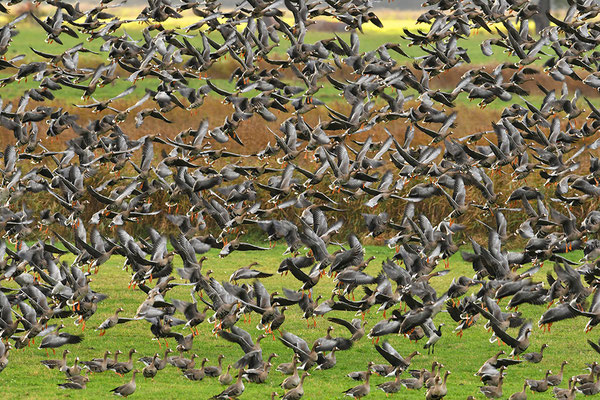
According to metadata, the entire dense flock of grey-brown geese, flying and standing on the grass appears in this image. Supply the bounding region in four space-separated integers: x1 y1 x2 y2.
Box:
0 0 600 400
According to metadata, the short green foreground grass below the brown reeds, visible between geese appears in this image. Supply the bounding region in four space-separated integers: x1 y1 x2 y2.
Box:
0 246 597 399
